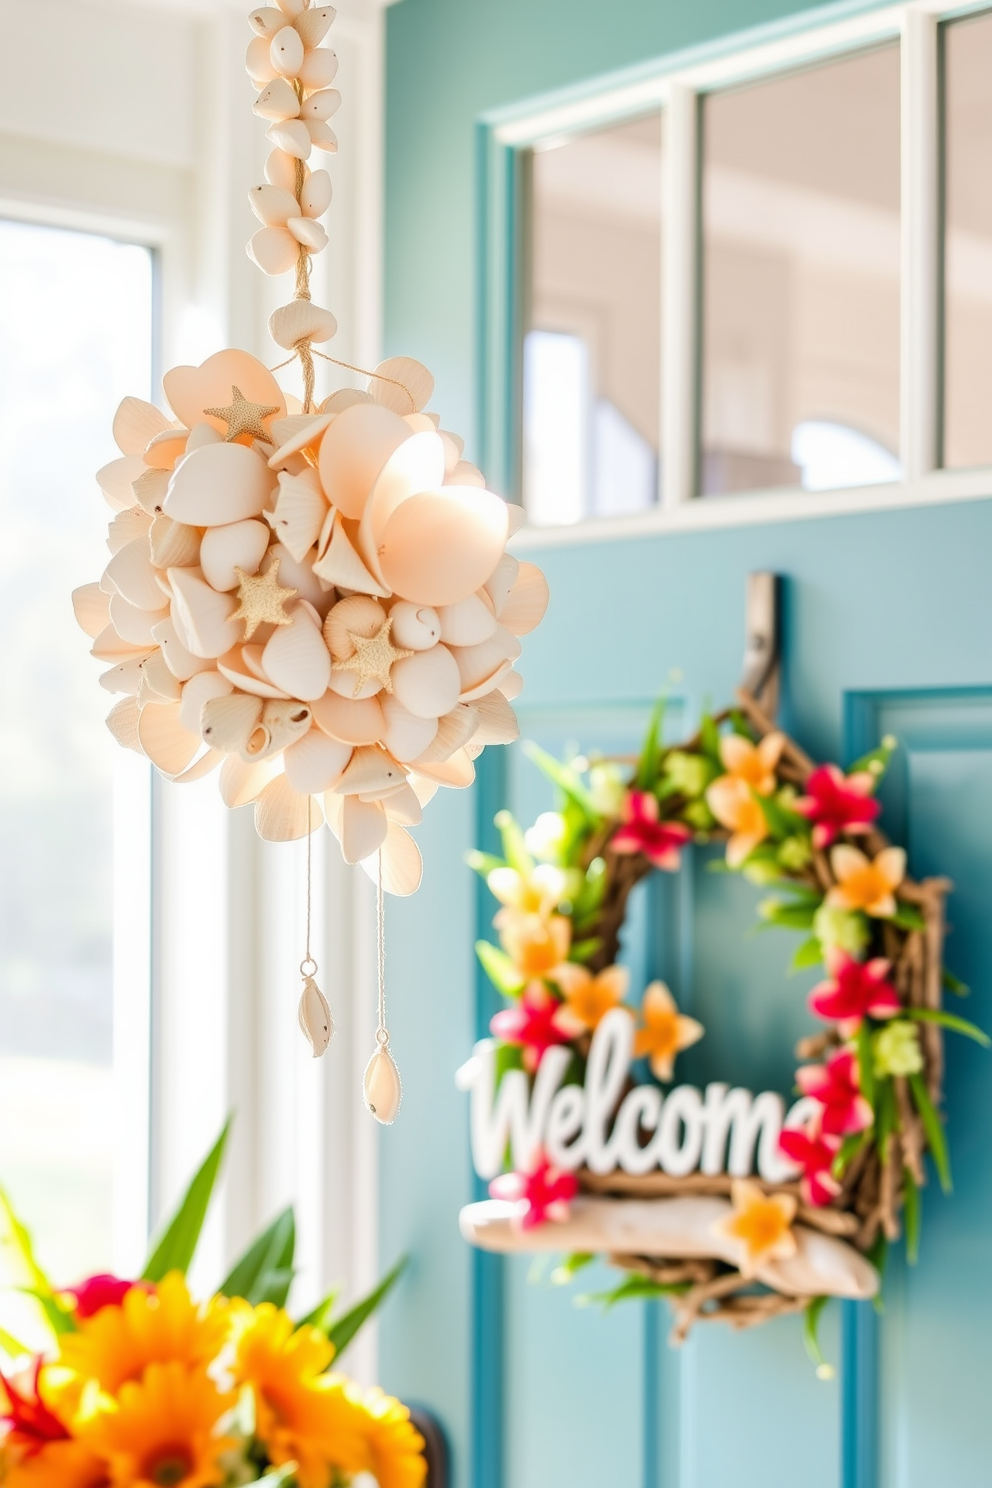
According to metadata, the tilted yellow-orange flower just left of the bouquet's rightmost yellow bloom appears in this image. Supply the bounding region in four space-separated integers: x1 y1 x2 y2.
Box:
233 1302 367 1488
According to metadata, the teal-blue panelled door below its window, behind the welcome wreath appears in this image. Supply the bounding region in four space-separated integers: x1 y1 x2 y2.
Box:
381 501 992 1488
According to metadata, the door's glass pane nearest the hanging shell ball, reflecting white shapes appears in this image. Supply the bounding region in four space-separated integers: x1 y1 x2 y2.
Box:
524 115 662 524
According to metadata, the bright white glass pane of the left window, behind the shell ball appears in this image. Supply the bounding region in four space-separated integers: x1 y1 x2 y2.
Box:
0 222 152 1318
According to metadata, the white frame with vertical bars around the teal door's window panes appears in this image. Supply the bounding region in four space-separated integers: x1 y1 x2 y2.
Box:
483 0 992 549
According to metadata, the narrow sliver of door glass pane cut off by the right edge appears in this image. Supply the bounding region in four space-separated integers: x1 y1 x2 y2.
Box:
943 13 992 466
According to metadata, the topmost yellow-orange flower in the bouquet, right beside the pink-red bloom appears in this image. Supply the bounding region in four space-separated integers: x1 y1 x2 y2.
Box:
61 1271 231 1394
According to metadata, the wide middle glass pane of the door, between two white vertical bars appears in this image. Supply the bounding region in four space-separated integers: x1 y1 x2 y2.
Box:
699 46 900 496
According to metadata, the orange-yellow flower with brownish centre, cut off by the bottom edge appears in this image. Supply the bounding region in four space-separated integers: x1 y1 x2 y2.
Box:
76 1362 235 1488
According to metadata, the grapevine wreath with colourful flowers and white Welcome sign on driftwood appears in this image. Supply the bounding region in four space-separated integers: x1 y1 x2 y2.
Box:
460 692 989 1359
